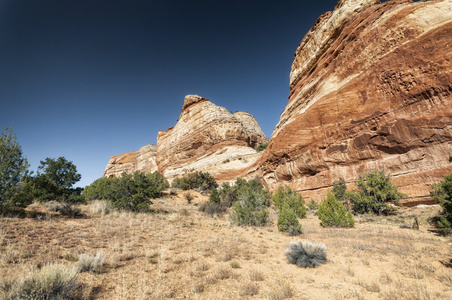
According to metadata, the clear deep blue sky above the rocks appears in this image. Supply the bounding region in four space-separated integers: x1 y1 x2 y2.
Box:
0 0 337 187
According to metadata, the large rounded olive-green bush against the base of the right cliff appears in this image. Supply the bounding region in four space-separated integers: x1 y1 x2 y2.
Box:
344 171 404 215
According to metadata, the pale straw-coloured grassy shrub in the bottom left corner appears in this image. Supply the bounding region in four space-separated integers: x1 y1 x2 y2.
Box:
4 263 80 300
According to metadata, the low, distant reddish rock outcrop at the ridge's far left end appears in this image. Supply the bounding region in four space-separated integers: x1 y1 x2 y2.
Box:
104 145 157 177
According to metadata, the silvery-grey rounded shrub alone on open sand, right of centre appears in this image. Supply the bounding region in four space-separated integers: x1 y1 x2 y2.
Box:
286 240 326 268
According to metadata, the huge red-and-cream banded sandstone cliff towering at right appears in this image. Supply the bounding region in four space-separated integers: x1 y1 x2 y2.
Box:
259 0 452 203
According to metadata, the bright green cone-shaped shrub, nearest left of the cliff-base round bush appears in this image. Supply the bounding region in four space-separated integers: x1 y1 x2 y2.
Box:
318 192 355 227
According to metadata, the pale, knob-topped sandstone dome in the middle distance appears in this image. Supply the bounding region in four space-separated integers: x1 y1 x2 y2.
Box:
157 95 268 180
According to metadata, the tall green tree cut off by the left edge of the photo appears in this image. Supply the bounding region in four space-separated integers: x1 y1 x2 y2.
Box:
0 128 30 214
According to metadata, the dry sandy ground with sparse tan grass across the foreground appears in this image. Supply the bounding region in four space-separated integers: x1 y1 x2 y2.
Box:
0 191 452 299
